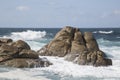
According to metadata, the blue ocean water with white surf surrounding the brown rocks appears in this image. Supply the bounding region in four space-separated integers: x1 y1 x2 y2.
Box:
0 28 120 80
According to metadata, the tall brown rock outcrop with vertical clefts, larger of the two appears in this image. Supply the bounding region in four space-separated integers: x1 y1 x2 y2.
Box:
38 26 112 66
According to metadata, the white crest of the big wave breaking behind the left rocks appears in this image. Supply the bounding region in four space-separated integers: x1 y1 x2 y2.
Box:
3 30 46 40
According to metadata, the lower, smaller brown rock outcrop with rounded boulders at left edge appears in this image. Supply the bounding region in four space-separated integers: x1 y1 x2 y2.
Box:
0 39 52 68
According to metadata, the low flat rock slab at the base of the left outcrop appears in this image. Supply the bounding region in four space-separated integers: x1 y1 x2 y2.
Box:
0 58 52 68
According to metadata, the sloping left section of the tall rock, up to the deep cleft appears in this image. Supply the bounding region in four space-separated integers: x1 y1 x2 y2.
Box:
38 27 74 57
